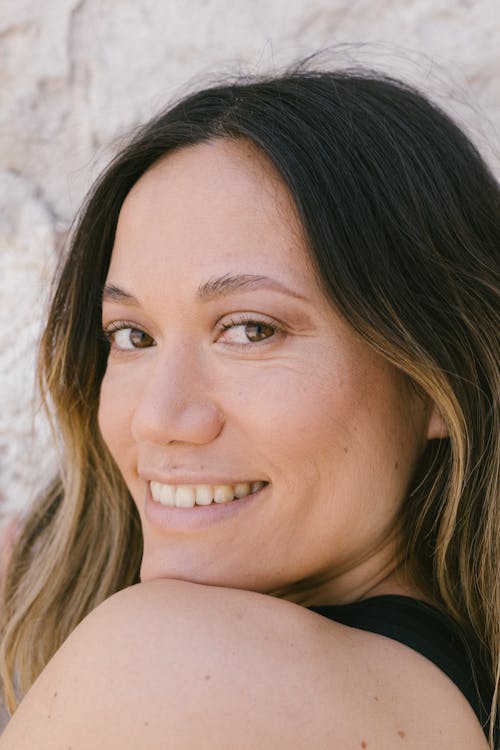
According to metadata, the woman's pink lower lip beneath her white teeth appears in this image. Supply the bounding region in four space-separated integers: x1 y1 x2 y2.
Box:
144 483 269 532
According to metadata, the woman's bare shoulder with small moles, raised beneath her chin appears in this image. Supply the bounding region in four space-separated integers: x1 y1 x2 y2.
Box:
0 581 487 750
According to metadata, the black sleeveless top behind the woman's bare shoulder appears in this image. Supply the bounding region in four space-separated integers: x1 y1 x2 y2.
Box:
308 595 493 736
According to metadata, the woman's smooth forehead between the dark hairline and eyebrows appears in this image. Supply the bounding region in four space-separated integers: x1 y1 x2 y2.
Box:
110 139 313 292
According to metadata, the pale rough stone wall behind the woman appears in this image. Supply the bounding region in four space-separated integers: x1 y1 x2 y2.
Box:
0 0 500 516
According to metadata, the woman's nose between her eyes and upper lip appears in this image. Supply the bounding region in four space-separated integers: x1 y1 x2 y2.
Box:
131 340 224 445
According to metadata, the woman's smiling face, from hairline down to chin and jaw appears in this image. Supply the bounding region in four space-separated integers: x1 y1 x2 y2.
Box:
99 140 436 604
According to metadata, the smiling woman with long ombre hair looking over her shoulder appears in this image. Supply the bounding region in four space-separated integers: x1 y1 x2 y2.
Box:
0 70 500 750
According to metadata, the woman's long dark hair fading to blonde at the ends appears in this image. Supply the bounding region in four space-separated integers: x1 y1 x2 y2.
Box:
0 68 500 748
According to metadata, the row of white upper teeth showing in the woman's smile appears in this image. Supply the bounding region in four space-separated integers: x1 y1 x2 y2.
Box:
150 481 266 508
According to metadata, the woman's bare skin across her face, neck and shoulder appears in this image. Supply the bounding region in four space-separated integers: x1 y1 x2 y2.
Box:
0 141 486 750
